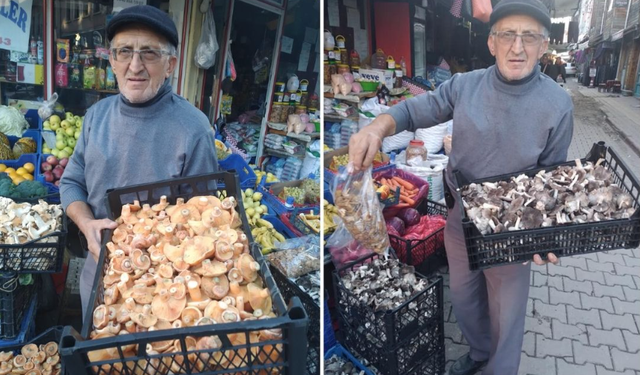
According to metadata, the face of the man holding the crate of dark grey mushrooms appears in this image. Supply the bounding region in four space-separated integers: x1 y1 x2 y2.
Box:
487 15 549 81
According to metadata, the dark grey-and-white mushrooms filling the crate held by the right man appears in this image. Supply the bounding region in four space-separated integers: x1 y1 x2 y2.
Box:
462 159 637 234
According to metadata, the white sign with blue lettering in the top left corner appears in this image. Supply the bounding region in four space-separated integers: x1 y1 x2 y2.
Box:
0 0 32 53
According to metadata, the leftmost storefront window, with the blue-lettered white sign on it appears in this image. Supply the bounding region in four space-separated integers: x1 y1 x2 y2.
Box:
0 0 45 112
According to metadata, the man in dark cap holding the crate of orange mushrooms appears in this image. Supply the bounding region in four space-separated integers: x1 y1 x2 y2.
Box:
60 5 217 312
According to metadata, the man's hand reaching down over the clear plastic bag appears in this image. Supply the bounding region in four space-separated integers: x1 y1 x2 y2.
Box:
349 114 396 171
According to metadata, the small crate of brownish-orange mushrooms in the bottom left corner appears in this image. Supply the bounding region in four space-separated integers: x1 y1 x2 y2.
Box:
0 341 62 375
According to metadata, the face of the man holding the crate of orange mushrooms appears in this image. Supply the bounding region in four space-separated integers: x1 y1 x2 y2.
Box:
109 26 177 103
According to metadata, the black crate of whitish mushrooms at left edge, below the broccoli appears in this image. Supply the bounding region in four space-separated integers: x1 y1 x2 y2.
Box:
0 197 63 271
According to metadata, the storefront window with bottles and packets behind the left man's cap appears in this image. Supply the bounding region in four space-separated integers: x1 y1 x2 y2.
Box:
53 0 184 115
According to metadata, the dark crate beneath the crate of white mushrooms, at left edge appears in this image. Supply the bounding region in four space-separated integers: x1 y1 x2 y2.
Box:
0 273 38 339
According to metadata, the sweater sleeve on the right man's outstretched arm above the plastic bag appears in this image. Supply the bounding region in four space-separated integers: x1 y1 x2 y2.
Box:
387 74 460 134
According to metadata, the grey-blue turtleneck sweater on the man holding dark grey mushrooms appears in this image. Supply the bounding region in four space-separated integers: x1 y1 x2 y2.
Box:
387 65 573 186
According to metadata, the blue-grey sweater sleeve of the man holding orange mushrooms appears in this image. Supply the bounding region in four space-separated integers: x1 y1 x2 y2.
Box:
60 110 93 211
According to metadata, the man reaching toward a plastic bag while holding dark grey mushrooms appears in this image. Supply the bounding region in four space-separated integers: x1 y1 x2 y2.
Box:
349 0 573 375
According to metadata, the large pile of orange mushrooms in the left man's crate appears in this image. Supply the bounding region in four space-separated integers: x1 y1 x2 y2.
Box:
89 196 282 374
